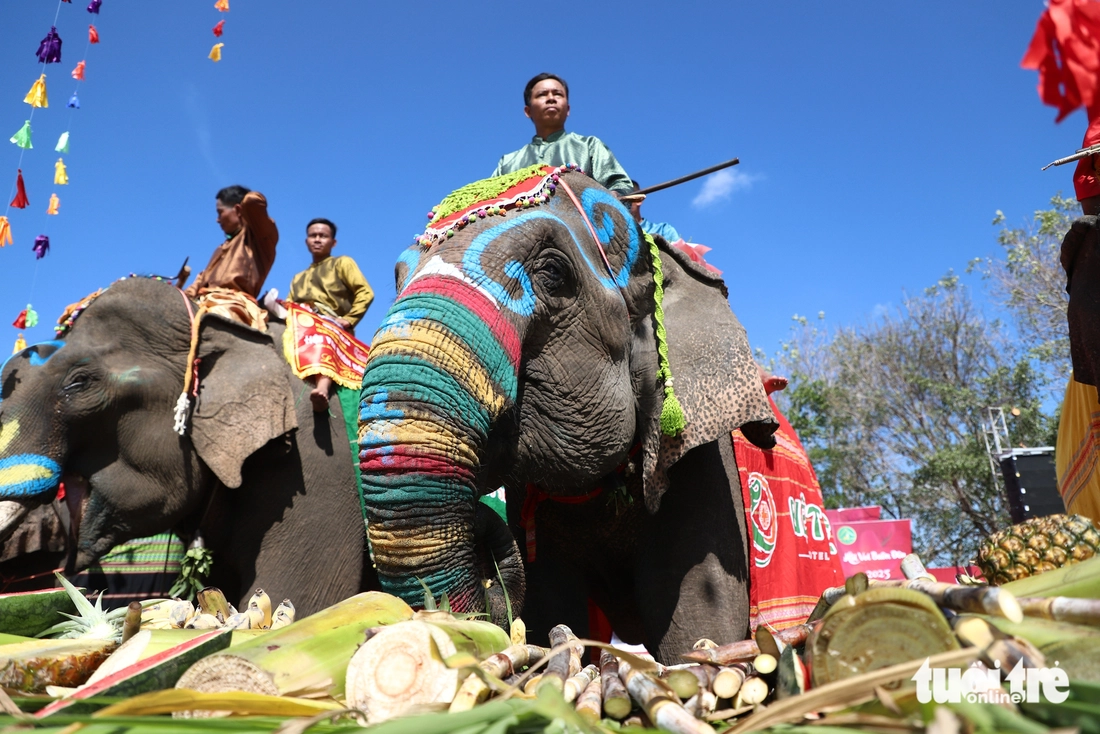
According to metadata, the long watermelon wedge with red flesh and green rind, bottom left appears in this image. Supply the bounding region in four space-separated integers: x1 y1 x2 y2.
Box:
34 628 232 719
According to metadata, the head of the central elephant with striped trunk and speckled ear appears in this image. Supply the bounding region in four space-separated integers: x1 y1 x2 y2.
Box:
360 172 774 621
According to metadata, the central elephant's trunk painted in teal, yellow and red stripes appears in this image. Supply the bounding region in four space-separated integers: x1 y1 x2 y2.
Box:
360 274 524 622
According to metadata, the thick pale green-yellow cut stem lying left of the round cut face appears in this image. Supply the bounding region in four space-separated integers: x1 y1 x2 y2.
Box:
176 591 413 698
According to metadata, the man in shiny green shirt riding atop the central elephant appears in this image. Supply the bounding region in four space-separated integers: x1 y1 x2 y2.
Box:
493 73 633 195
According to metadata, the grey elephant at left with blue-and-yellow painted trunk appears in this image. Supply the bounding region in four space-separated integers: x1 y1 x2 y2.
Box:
0 277 373 613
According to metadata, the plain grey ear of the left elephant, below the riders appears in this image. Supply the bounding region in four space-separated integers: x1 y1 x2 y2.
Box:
190 314 298 489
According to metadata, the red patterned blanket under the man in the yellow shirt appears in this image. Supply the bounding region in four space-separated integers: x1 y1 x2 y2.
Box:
283 303 370 390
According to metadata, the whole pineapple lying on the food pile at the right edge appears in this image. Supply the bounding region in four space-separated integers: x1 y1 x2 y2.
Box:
978 515 1100 584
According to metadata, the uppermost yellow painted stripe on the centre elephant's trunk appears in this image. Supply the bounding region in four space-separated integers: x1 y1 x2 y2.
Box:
371 321 504 416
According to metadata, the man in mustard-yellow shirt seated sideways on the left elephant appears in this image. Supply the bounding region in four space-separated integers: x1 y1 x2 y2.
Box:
287 218 374 413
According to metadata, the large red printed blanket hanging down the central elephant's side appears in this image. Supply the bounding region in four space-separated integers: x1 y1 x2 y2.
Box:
733 397 844 632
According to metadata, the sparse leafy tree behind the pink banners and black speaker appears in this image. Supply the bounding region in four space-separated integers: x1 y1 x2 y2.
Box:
778 274 1053 563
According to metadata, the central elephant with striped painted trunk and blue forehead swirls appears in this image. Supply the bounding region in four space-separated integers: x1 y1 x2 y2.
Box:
360 171 776 660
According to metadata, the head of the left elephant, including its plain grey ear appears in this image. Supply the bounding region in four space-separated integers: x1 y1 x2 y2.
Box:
0 277 296 570
